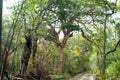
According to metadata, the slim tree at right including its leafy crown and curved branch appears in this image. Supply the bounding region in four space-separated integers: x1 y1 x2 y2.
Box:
86 0 119 76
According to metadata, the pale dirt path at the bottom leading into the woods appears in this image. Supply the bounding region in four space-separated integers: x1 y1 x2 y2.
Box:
69 72 95 80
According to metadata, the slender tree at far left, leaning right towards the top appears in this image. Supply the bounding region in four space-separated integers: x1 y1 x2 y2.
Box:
0 1 24 80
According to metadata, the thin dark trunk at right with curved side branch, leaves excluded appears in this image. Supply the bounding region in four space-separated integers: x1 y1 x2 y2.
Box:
102 0 120 75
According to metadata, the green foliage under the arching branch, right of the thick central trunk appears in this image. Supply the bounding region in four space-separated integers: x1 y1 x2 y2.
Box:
63 35 90 76
